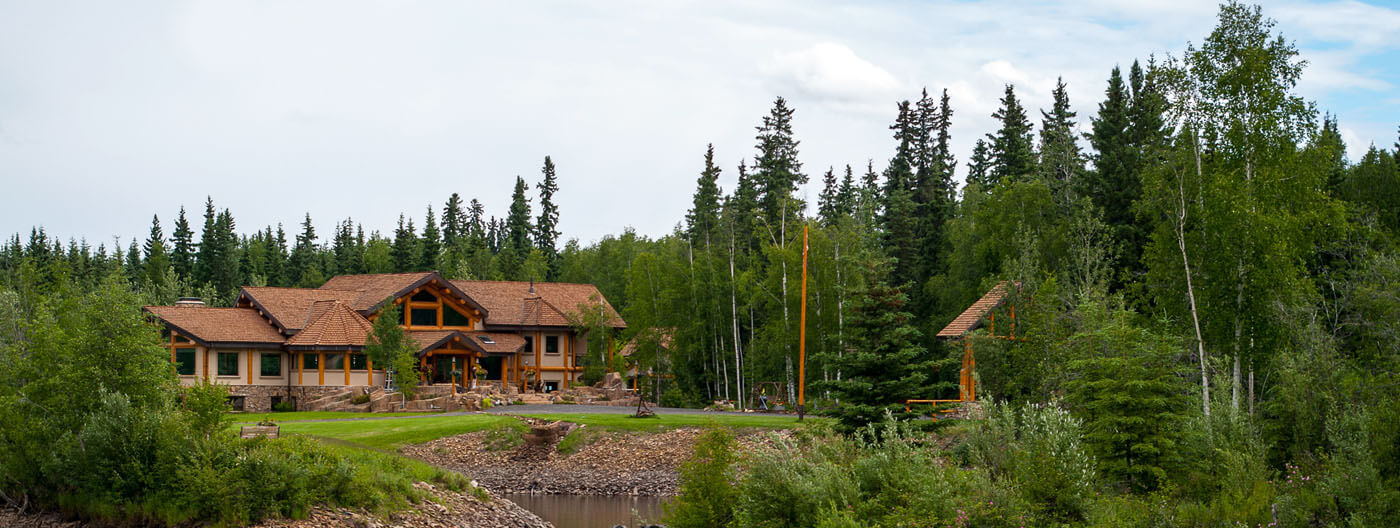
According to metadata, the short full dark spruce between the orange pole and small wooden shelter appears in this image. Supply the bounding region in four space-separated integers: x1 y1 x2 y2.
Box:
818 260 938 431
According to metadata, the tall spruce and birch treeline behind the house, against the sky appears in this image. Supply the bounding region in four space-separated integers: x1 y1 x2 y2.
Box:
0 4 1400 414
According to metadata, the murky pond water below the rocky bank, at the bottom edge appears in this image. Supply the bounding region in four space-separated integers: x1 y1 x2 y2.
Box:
501 493 666 528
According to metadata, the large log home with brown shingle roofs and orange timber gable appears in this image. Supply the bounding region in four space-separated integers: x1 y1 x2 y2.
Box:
146 272 626 410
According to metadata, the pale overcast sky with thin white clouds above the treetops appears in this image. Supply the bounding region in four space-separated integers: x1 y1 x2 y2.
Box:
0 0 1400 245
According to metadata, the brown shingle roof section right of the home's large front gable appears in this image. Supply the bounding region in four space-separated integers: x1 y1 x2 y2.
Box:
452 280 627 328
